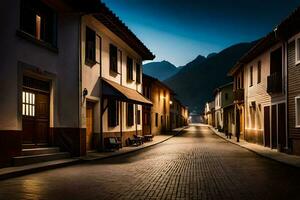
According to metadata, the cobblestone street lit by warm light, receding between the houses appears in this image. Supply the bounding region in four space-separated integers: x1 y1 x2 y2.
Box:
0 125 300 200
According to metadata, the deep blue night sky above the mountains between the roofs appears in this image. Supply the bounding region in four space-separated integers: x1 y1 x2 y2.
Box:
103 0 300 66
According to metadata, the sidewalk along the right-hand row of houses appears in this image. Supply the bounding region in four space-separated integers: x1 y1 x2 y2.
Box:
207 125 300 168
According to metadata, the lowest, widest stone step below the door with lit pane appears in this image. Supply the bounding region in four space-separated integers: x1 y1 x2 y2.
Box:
13 152 71 166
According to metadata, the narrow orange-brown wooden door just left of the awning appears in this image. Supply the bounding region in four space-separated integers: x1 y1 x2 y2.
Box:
86 102 94 150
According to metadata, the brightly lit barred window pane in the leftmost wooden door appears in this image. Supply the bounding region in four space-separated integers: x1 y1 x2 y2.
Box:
22 91 35 117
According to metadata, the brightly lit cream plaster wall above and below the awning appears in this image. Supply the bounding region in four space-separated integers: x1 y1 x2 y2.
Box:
81 15 142 132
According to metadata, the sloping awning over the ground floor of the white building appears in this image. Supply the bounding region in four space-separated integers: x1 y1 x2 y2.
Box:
102 78 152 105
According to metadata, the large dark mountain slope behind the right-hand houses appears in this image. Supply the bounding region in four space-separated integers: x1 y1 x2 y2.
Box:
164 41 256 113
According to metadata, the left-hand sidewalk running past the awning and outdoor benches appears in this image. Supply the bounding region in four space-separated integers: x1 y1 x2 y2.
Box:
0 127 187 180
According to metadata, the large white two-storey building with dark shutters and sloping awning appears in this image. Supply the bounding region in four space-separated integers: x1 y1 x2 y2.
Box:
0 0 154 166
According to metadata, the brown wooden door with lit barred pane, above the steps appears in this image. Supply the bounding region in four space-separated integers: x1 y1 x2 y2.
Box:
22 89 49 144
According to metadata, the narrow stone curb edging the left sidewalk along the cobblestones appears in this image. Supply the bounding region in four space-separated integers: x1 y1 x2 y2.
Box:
0 126 188 180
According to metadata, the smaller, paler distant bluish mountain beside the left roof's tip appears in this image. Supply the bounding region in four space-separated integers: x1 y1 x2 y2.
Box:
143 60 179 81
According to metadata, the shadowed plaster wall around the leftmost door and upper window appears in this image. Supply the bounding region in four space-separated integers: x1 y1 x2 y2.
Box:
0 0 79 130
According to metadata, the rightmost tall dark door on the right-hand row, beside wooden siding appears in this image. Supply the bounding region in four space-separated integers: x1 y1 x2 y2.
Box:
278 103 286 151
